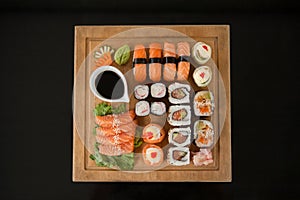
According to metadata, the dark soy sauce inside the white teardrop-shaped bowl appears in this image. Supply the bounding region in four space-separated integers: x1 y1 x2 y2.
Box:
95 71 124 99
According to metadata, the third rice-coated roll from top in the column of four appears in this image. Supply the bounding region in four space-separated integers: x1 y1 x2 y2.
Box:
168 127 192 147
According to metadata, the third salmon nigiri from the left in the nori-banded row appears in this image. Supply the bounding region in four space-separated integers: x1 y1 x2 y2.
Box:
163 42 176 81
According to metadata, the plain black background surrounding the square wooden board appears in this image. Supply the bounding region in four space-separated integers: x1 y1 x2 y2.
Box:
0 0 300 199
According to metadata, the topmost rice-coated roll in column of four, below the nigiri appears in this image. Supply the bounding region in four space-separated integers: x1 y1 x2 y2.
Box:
168 82 191 104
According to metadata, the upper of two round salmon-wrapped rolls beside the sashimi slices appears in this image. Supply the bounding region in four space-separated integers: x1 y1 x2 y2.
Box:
142 124 166 144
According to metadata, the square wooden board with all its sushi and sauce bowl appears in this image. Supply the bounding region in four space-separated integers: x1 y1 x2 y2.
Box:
73 25 232 182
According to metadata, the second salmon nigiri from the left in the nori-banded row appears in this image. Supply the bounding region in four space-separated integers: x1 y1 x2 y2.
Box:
149 43 162 82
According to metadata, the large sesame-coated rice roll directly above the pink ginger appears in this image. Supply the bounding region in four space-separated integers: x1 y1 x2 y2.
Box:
194 120 214 148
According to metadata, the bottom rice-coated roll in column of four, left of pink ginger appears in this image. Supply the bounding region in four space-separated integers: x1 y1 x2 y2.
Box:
167 147 190 166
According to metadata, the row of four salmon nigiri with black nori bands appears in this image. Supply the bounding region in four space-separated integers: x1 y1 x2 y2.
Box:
133 42 190 82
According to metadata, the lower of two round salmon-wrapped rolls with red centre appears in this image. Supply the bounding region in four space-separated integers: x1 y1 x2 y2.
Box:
143 144 164 166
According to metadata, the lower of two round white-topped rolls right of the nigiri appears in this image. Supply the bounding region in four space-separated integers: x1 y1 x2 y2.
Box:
193 66 212 87
